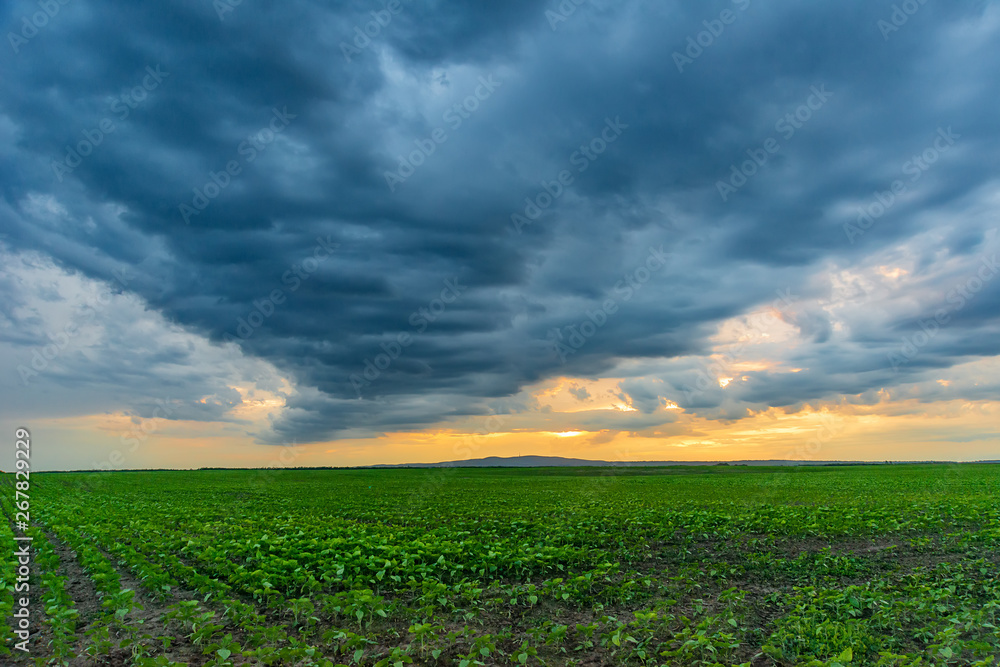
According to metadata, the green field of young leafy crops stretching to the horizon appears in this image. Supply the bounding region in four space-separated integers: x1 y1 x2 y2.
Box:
0 464 1000 667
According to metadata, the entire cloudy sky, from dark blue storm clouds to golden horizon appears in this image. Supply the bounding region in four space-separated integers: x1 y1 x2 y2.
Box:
0 0 1000 469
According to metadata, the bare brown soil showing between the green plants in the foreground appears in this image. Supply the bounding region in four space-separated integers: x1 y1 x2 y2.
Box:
13 520 984 667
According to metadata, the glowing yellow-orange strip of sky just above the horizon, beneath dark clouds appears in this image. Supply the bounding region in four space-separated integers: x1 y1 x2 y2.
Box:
23 381 1000 470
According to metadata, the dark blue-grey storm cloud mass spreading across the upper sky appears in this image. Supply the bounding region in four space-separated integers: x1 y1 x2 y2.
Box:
0 0 1000 442
